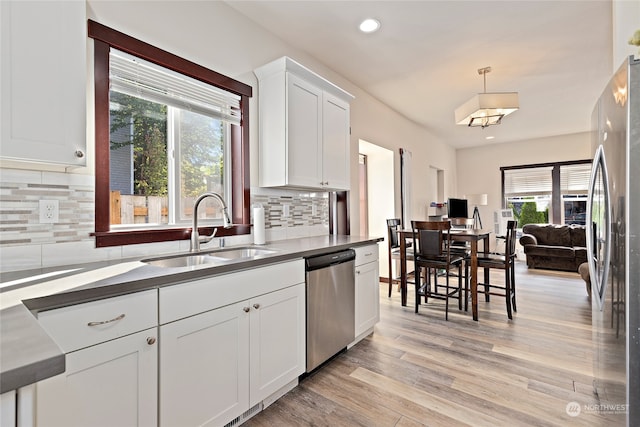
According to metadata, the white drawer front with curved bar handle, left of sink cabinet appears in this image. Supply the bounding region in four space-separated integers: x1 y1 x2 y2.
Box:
38 289 158 353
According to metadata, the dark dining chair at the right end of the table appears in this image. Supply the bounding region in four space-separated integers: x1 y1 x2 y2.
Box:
478 221 517 319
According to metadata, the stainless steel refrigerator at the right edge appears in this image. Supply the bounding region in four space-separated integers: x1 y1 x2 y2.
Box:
587 57 640 426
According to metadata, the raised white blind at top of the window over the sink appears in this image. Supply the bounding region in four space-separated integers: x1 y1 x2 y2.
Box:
109 48 241 124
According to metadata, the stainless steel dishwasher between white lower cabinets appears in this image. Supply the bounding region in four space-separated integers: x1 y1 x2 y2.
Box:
305 249 356 372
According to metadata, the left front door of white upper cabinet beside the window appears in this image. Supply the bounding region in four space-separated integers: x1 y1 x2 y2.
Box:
287 73 322 188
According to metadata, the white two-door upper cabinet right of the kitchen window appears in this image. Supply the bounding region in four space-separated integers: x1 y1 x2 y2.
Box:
255 57 353 191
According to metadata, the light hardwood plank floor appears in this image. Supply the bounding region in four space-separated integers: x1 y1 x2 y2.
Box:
245 262 615 427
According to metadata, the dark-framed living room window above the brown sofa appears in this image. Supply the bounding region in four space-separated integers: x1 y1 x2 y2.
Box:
500 160 591 227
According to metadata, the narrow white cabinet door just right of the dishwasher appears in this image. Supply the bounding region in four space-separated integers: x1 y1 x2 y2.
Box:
355 262 380 337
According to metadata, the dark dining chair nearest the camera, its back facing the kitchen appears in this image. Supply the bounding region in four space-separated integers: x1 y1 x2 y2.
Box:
411 220 468 320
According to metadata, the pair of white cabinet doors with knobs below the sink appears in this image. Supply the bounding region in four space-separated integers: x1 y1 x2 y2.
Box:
160 284 305 427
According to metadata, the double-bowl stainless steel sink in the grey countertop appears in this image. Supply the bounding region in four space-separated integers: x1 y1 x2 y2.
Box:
142 247 277 268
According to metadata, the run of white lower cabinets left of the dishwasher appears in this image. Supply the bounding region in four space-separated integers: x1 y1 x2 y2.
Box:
28 259 306 427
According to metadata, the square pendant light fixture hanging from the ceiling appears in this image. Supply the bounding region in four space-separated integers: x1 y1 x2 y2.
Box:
455 67 519 129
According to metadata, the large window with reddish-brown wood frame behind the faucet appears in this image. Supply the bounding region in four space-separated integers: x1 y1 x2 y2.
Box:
89 21 251 247
